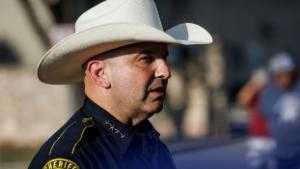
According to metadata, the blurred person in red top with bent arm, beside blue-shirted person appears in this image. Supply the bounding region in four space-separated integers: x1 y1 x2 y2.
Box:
238 68 274 169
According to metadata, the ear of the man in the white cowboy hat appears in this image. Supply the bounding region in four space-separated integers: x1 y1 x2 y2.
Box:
85 60 111 89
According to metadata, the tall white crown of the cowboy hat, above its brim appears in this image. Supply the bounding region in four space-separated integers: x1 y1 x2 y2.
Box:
75 0 163 32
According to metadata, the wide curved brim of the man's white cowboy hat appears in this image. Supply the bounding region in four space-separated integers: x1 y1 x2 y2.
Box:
38 23 212 84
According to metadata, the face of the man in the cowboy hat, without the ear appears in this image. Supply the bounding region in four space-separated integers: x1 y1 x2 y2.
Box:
106 43 171 116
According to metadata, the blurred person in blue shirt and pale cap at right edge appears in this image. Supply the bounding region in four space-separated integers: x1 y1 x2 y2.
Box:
260 52 300 169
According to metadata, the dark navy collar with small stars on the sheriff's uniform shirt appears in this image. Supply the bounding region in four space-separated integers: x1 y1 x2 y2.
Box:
82 97 159 155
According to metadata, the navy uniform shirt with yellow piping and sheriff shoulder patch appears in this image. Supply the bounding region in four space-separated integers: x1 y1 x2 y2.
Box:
29 98 175 169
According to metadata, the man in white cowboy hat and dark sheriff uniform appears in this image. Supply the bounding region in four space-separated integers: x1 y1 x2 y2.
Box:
29 0 212 169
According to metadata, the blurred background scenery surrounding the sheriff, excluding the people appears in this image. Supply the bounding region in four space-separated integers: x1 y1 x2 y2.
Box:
0 0 300 169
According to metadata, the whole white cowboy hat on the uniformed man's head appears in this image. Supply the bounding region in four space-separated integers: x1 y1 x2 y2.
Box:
38 0 212 84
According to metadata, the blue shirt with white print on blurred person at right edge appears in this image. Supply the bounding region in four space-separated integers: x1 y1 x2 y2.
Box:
260 80 300 158
